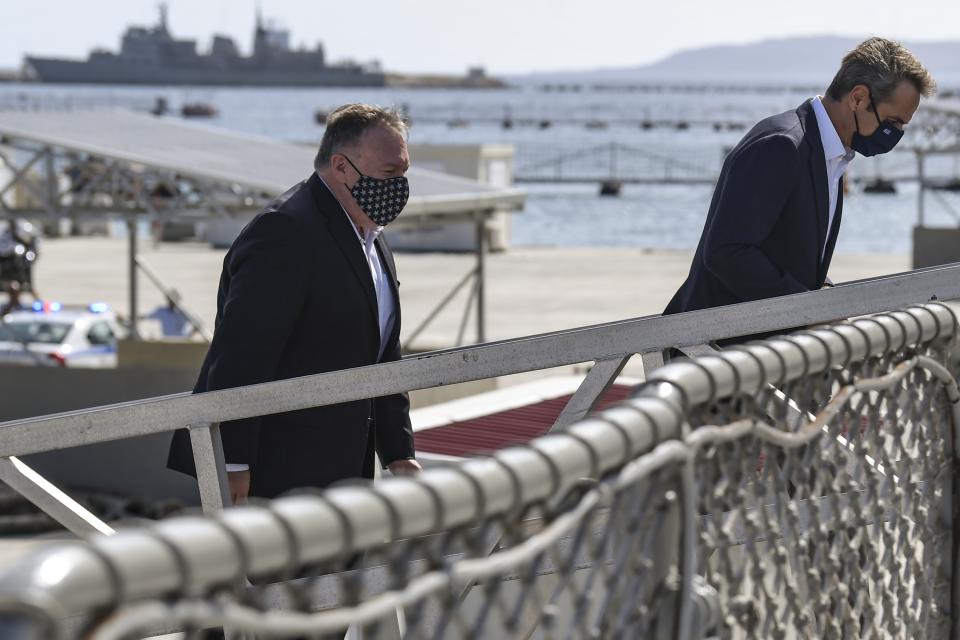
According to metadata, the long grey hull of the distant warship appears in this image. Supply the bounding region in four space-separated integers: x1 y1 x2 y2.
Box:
26 57 386 87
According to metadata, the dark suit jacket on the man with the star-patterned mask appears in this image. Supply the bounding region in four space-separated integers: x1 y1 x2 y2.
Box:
168 174 414 497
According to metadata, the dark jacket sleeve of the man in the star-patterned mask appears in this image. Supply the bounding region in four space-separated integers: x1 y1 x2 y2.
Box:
207 212 306 464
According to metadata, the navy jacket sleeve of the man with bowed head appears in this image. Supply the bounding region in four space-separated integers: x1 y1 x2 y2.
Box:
703 135 815 300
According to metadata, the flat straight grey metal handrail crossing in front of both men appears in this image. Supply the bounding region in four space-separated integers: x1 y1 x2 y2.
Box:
0 263 960 457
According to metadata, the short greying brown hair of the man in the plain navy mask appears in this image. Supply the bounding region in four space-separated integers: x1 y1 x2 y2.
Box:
827 38 937 102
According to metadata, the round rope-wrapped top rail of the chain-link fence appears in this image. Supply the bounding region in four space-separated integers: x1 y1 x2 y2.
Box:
0 305 960 637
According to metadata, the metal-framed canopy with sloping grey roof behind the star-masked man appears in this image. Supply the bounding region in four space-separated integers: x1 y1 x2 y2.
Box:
0 110 525 342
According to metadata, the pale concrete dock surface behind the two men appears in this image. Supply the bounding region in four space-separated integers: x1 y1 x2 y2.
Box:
35 237 910 348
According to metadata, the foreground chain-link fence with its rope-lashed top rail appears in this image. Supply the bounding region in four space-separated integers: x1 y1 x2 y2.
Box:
0 304 960 639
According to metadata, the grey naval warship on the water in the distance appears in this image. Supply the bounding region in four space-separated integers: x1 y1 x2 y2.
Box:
24 4 386 87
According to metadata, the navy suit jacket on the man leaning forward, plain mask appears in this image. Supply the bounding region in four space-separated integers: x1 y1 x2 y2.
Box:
664 101 843 314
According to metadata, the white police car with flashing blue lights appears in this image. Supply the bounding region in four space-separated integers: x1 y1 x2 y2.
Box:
0 301 120 368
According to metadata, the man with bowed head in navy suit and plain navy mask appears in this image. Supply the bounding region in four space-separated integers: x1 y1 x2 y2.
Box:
664 38 934 314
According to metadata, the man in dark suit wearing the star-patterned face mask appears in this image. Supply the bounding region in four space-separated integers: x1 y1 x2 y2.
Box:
169 104 420 503
